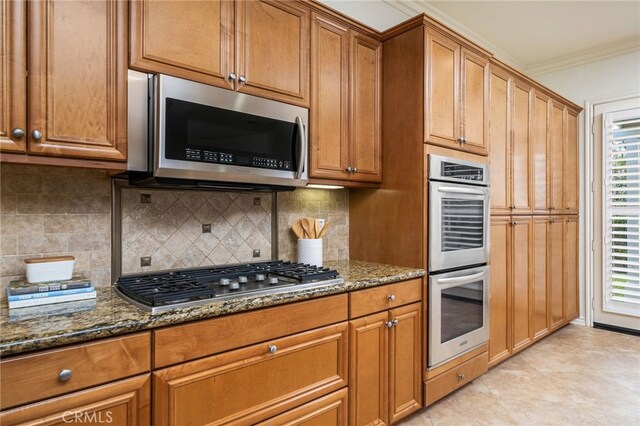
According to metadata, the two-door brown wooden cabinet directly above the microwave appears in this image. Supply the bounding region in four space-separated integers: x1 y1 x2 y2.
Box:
130 0 310 107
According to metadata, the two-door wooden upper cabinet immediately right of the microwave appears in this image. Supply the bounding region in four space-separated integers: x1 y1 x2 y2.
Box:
310 13 382 186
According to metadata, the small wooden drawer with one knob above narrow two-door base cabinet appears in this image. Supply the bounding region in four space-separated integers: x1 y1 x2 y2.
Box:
349 278 422 318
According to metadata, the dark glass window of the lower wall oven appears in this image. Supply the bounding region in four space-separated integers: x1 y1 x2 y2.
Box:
440 280 484 343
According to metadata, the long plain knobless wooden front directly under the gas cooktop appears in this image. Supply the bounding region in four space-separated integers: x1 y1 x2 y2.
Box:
154 294 348 368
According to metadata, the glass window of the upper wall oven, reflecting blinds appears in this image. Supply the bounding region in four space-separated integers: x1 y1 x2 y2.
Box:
441 198 484 252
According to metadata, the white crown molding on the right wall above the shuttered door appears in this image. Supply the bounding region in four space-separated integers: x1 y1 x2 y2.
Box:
524 37 640 77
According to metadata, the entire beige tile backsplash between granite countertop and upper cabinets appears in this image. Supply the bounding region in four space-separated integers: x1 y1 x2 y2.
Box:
0 163 349 298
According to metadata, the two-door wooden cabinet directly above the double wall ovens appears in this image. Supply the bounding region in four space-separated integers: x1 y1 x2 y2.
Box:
424 28 489 155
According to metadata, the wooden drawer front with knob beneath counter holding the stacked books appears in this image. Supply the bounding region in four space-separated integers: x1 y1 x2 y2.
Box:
0 333 151 409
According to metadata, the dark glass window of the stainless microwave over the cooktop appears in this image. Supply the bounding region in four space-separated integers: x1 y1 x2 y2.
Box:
165 98 298 170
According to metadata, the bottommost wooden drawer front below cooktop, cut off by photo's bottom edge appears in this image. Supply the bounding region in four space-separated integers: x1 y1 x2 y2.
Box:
258 388 347 426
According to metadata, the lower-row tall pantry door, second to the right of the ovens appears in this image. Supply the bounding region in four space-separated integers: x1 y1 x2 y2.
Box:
511 217 533 353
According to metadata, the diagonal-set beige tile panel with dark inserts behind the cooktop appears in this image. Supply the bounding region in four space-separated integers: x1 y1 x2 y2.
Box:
122 188 272 274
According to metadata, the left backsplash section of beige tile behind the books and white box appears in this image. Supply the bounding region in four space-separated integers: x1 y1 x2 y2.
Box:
0 164 111 297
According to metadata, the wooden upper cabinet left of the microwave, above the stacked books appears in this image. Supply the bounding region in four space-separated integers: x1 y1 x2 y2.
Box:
0 0 128 165
